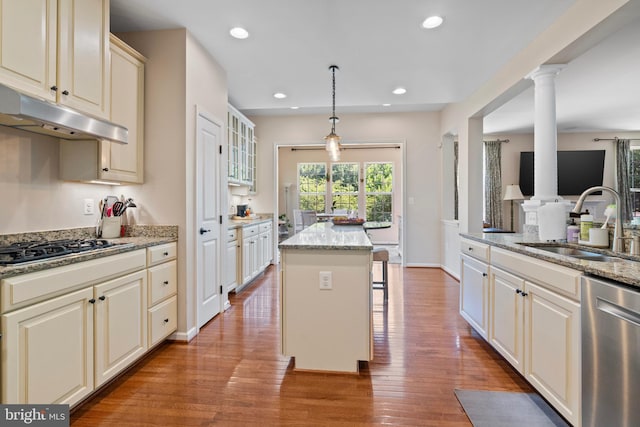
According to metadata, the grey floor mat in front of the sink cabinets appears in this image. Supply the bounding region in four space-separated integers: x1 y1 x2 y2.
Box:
455 389 569 427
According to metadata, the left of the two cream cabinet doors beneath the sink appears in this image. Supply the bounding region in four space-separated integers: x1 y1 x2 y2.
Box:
488 267 525 372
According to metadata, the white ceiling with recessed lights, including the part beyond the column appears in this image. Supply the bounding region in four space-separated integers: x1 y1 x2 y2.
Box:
111 0 640 133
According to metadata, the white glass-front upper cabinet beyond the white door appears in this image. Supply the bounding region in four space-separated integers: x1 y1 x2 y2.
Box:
227 105 256 193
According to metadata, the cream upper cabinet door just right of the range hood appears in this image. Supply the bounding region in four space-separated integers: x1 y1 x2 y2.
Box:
100 36 144 184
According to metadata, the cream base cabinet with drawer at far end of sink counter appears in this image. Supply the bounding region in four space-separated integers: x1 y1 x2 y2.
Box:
460 239 489 339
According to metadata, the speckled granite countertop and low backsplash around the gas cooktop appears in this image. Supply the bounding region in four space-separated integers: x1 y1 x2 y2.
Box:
0 226 178 279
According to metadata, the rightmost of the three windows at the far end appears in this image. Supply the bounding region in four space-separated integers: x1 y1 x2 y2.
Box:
364 163 393 221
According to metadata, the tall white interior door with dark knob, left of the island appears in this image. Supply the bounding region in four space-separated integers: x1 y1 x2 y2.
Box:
196 112 223 328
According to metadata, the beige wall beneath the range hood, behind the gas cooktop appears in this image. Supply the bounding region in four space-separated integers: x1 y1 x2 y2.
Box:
0 127 121 234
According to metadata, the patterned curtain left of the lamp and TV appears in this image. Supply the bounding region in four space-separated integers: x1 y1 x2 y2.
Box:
484 141 502 228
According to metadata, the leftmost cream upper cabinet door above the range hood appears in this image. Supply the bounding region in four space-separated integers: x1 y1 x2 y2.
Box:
0 0 57 101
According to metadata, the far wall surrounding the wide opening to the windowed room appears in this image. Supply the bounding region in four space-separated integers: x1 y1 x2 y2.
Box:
250 112 441 266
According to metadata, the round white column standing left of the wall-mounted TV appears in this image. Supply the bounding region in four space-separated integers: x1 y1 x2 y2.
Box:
527 65 564 201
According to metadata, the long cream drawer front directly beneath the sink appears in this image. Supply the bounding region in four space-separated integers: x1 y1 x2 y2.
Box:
491 248 582 300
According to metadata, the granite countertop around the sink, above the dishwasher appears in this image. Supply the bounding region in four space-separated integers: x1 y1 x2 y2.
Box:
460 233 640 288
